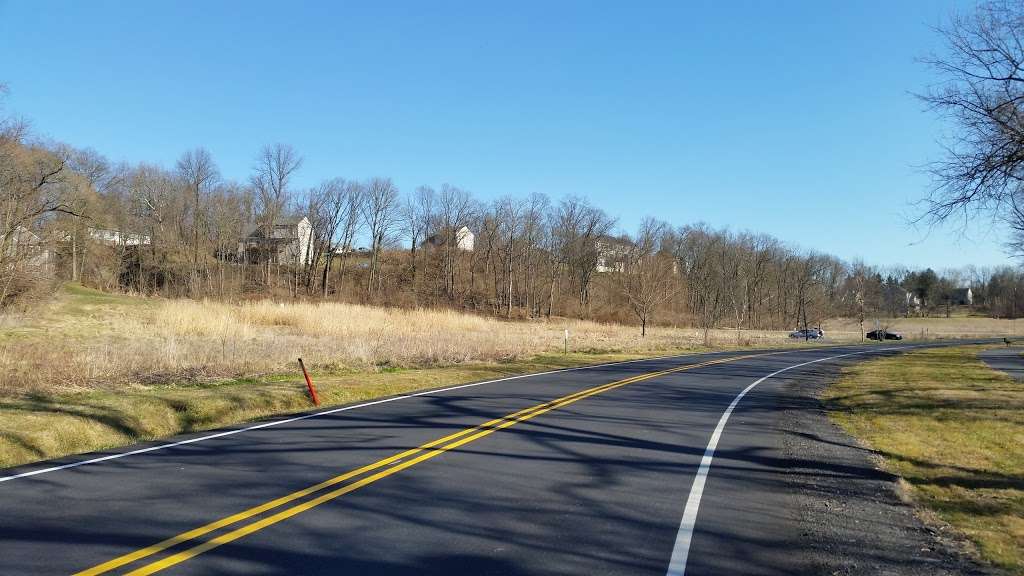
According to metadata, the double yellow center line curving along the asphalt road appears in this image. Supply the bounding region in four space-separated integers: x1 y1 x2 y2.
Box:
75 353 765 576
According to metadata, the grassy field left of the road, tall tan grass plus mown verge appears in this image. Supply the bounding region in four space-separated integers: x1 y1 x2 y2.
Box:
0 286 802 467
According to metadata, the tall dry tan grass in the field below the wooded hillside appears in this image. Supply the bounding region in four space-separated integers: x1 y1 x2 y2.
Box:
0 296 786 394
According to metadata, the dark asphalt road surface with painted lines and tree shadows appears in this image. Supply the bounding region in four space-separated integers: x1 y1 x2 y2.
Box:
0 345 974 575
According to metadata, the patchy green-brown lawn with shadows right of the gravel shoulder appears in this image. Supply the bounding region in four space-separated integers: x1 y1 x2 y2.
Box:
825 346 1024 575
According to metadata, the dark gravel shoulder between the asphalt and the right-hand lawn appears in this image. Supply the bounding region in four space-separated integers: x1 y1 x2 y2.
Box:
779 360 991 576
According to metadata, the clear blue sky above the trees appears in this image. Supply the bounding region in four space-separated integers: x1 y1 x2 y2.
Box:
0 0 1009 269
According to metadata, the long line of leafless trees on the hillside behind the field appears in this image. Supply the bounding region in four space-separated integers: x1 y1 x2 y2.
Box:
0 88 1024 334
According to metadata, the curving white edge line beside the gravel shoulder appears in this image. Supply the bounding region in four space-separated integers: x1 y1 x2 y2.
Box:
666 345 921 576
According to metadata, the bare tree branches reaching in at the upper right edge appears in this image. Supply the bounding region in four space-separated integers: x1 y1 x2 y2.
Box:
921 1 1024 237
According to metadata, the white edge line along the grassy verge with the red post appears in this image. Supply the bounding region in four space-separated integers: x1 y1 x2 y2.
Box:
0 351 733 484
